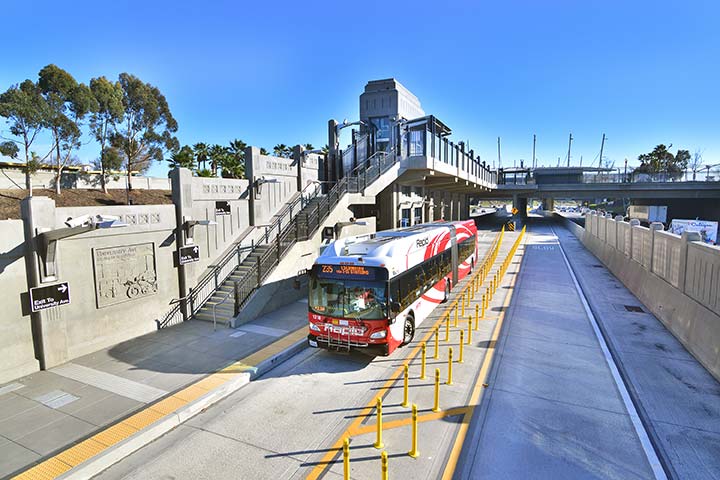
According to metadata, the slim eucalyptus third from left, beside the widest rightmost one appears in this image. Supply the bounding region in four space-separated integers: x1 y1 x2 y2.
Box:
90 77 125 193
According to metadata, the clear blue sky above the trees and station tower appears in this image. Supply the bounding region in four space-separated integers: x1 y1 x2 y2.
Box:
0 0 720 176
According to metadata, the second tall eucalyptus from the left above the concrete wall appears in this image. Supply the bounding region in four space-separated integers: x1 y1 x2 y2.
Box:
38 64 97 195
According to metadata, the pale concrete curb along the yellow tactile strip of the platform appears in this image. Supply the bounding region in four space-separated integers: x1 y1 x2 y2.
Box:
57 338 307 480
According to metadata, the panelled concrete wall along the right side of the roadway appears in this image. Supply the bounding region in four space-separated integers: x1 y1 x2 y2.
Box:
564 214 720 380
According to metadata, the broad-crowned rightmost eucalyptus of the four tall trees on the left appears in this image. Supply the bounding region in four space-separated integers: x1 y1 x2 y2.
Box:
112 73 179 204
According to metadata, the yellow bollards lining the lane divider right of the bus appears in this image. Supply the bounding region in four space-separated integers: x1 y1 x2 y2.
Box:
343 227 512 480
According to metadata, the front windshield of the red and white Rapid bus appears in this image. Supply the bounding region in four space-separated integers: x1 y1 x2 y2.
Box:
309 278 387 320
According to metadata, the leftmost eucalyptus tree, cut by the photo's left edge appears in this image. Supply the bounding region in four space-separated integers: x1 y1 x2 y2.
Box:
0 80 48 196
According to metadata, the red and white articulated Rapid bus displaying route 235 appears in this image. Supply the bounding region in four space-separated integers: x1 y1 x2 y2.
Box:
308 220 478 355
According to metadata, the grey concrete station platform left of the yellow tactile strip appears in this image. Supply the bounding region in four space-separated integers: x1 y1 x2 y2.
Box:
0 300 307 477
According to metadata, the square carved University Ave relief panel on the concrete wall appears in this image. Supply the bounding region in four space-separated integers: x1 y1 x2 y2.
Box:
93 243 158 308
